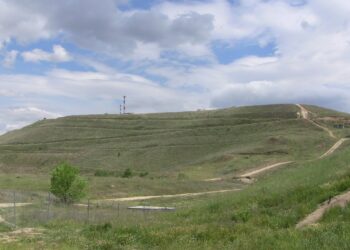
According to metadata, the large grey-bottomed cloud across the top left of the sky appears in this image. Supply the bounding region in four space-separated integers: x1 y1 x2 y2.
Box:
0 0 213 59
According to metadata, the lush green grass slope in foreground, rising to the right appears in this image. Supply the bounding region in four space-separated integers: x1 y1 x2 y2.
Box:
4 142 350 249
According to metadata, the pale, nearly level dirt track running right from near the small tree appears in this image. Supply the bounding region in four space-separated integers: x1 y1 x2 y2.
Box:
95 188 240 203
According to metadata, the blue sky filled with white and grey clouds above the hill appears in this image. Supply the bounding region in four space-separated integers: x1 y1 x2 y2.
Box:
0 0 350 134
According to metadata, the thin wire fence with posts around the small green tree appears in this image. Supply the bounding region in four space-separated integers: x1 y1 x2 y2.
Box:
0 191 175 227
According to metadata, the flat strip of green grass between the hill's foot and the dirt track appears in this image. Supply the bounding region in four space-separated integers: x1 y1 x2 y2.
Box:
0 174 242 202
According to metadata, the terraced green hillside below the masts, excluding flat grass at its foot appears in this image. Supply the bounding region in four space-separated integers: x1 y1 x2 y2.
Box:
0 105 337 172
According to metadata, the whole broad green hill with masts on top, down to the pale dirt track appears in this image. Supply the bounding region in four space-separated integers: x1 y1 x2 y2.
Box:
0 102 338 197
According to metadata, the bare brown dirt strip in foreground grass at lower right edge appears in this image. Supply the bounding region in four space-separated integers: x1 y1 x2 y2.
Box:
296 189 350 228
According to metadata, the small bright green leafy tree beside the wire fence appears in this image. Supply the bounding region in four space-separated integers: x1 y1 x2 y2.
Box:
50 163 87 203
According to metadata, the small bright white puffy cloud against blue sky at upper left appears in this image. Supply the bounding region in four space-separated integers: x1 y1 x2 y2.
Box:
21 45 71 62
